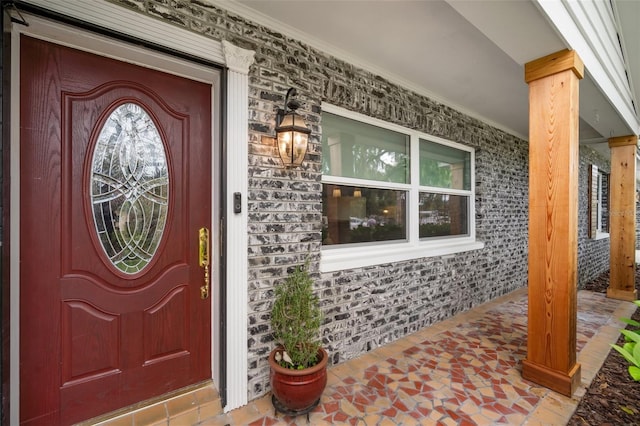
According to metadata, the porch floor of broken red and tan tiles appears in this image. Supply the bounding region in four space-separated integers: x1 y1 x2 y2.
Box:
95 288 636 426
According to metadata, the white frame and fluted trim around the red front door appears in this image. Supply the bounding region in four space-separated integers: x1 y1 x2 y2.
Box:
9 0 254 424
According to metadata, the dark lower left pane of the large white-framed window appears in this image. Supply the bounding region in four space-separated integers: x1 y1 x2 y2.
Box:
322 184 407 245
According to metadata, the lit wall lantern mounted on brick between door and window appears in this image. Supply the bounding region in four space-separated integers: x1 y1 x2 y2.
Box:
276 87 311 167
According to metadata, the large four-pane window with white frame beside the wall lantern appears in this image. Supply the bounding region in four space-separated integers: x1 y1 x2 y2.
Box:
322 105 479 269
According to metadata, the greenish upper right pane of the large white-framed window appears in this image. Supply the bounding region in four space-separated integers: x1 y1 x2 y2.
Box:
420 139 471 190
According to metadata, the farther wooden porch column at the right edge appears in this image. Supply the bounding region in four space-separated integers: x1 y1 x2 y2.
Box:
607 135 638 301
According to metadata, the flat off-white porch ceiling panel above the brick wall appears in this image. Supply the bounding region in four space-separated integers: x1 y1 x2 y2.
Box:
226 0 528 139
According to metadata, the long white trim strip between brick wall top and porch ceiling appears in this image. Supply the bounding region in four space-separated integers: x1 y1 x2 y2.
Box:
212 0 529 140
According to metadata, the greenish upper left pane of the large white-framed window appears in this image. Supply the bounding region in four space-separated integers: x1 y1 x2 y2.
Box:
322 112 409 183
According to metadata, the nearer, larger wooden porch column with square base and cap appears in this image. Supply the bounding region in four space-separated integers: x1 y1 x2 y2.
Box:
522 50 584 396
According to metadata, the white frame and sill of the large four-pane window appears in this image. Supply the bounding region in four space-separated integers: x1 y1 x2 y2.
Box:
320 104 484 272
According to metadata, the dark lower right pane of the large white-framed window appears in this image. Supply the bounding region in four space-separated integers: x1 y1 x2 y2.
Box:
419 192 469 238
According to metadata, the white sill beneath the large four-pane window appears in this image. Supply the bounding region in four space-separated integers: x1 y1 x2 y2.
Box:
320 239 484 272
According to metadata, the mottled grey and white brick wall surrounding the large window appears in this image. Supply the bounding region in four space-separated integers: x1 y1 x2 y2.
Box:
110 0 608 400
